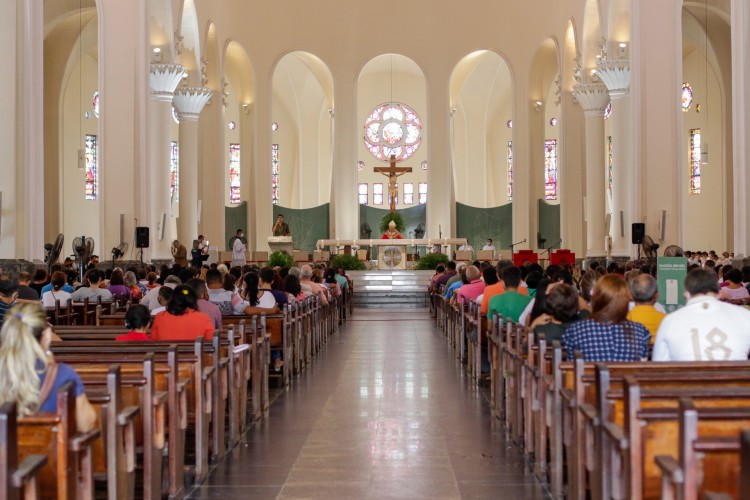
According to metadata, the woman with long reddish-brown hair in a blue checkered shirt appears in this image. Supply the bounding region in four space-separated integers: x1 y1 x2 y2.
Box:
562 274 651 362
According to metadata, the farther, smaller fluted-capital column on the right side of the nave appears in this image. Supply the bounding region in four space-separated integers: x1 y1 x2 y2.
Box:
573 83 609 258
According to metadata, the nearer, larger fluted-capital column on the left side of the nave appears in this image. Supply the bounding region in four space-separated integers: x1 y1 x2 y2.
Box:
148 64 185 259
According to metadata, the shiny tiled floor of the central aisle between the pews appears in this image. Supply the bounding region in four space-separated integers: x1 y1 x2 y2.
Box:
191 309 548 499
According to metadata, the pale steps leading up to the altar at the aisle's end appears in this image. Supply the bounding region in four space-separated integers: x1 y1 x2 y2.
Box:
347 270 435 309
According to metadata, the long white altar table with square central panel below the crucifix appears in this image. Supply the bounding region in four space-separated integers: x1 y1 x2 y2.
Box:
317 238 466 270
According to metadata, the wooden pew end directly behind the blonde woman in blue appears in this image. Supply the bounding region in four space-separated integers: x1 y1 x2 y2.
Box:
16 382 101 500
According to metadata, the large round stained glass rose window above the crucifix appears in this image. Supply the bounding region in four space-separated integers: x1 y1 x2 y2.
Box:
364 103 422 161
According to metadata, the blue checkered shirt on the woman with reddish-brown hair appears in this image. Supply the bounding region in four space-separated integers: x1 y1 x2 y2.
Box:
562 319 651 362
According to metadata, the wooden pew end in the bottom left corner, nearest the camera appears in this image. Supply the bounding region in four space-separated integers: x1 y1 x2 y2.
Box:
0 403 47 500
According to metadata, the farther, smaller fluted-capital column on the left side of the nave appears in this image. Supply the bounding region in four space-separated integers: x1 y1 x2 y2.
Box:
174 87 211 248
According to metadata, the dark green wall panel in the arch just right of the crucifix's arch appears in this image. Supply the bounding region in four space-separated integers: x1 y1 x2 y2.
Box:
456 203 513 250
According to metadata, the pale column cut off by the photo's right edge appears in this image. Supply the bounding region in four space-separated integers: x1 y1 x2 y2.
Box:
730 0 750 256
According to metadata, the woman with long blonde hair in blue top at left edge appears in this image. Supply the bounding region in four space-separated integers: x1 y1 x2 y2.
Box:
0 304 96 432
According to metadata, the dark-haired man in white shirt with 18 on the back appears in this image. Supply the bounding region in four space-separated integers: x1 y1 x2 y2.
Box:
652 269 750 361
